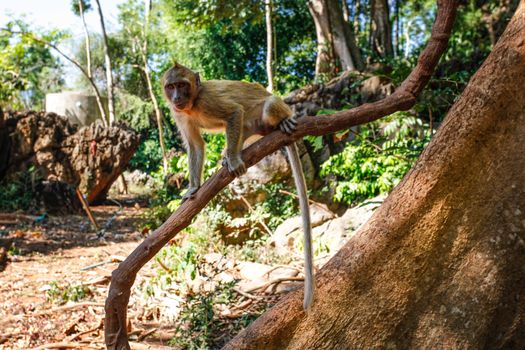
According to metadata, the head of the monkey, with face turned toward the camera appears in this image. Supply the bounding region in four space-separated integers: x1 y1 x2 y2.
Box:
164 65 200 111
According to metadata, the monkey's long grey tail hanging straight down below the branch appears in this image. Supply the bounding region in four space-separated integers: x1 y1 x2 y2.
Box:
286 143 314 311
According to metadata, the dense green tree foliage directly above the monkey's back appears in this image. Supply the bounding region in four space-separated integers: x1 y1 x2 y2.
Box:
163 0 315 92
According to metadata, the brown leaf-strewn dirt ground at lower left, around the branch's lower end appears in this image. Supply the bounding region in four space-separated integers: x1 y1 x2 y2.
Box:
0 203 173 350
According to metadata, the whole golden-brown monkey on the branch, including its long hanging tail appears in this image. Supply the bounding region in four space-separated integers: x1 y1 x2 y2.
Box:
162 63 314 310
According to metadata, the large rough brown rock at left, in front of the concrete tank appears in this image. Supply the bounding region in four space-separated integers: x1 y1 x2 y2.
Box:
0 112 139 203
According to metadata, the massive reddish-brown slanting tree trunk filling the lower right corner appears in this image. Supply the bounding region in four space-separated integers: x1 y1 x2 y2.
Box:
225 1 525 350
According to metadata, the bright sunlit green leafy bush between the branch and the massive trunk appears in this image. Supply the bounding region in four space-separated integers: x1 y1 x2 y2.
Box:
321 112 431 204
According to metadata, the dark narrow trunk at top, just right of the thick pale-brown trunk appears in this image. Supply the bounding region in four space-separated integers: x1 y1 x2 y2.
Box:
370 0 394 57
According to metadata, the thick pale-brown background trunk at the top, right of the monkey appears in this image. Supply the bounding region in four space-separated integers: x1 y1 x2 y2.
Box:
308 0 364 75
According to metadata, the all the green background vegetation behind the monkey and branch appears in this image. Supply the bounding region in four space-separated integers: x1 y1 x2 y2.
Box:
0 0 517 349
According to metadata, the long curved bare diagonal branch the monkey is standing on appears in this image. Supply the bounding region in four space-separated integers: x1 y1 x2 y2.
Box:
104 0 458 349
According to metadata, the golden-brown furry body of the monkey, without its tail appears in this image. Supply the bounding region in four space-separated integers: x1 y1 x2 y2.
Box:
163 64 292 183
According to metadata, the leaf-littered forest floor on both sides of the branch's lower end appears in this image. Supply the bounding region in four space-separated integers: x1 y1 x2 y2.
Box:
0 197 294 350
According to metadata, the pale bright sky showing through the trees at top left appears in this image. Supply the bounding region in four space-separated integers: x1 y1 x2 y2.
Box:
0 0 125 87
